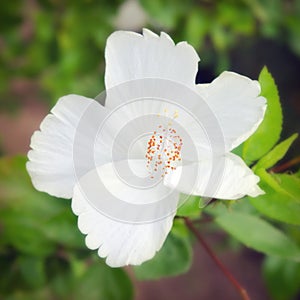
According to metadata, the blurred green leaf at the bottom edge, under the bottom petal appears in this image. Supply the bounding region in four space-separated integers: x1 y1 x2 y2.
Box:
72 259 133 300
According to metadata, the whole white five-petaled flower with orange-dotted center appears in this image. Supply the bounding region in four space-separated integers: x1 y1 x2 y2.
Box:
27 30 266 267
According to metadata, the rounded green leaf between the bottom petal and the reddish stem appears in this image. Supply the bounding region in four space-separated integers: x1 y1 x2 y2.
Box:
134 220 192 280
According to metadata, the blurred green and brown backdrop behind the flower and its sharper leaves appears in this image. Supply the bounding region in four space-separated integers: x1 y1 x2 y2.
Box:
0 0 300 300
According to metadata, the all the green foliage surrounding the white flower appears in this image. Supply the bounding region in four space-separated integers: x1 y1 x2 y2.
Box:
0 0 300 300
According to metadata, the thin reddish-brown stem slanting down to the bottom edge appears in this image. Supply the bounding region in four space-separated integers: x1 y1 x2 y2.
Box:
183 217 250 300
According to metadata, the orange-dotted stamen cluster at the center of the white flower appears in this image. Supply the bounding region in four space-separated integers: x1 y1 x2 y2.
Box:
145 124 183 178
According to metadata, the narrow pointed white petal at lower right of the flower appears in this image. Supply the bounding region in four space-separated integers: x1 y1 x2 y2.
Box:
165 153 264 200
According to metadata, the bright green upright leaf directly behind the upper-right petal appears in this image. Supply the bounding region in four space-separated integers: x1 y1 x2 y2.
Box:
243 67 282 161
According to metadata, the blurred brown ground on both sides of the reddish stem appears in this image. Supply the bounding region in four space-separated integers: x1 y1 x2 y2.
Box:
136 244 270 300
